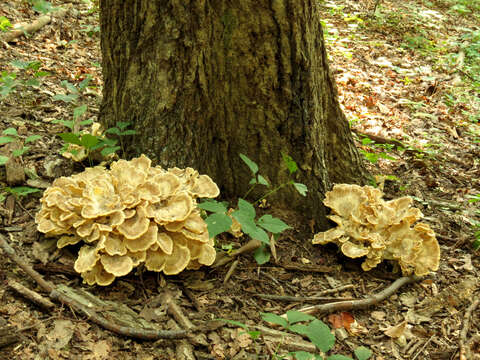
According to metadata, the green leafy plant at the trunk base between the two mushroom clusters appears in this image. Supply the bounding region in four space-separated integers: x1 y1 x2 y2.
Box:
198 154 307 264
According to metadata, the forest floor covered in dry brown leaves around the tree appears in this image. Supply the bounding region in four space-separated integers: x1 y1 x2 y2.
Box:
0 0 480 360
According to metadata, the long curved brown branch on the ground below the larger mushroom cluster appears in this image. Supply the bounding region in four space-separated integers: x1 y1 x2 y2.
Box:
0 234 193 340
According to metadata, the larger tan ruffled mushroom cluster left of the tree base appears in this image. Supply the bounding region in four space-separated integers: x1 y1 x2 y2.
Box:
35 155 220 286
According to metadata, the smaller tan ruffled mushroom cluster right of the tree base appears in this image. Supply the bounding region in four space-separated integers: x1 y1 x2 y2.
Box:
312 184 440 276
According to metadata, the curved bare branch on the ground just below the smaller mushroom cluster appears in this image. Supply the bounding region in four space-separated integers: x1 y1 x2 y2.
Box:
288 275 421 314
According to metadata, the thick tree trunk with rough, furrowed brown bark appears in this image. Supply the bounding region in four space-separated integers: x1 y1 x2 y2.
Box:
100 0 366 225
